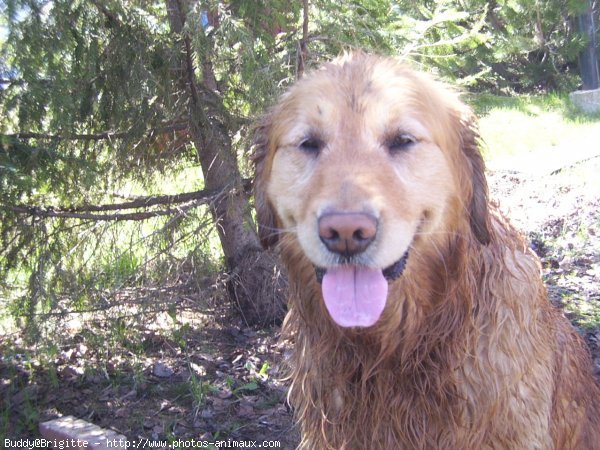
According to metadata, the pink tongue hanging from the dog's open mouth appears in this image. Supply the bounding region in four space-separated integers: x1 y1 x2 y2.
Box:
322 266 388 327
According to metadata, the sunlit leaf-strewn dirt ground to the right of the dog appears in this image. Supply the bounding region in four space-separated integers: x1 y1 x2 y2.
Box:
488 155 600 370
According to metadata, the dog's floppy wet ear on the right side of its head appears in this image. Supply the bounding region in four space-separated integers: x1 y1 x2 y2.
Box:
460 115 490 245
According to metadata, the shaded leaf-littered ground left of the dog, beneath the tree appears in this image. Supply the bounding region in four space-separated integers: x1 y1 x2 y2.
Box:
0 290 298 449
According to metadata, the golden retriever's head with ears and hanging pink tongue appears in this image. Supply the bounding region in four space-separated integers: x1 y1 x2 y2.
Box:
255 53 489 326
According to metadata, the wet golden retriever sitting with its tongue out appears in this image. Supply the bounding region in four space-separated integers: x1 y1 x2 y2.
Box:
255 53 600 450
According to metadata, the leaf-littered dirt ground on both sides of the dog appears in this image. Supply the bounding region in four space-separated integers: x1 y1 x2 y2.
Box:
0 157 600 449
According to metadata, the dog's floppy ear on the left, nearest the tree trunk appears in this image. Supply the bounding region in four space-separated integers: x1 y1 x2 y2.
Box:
252 114 277 248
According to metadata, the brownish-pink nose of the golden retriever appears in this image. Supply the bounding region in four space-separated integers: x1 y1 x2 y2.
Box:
319 212 377 257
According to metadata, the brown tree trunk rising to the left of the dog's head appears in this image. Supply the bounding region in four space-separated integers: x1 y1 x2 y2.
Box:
166 0 285 324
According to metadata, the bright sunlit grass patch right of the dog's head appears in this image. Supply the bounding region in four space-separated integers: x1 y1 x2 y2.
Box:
466 94 600 161
